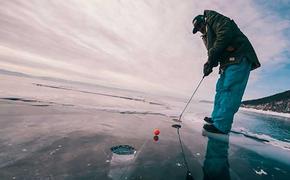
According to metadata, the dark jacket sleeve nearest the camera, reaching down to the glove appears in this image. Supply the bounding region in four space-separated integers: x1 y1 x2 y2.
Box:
208 15 233 67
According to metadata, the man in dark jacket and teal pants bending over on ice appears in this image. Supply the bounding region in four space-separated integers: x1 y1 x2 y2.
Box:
192 10 261 134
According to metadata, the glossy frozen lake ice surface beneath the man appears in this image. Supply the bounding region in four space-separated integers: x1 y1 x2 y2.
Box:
0 76 290 180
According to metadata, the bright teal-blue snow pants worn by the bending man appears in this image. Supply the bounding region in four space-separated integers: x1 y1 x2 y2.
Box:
211 57 251 133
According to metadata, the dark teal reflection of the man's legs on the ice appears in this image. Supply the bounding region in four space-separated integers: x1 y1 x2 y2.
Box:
203 136 231 180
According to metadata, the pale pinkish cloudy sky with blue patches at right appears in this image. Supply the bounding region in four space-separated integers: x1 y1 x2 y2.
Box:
0 0 290 100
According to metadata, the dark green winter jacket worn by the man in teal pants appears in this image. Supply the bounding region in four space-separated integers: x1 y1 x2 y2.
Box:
202 10 261 70
